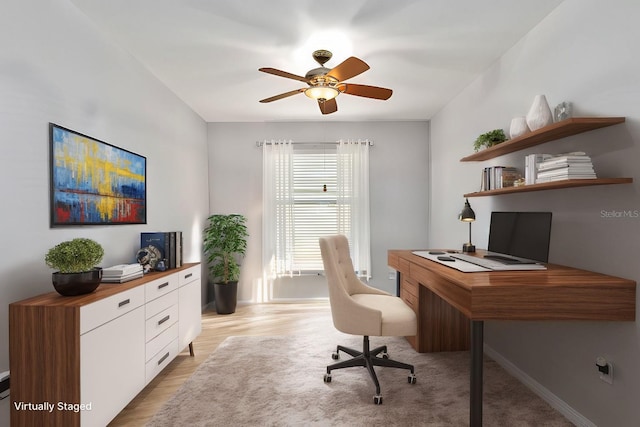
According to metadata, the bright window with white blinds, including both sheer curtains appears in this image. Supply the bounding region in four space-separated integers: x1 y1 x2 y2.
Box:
262 141 370 280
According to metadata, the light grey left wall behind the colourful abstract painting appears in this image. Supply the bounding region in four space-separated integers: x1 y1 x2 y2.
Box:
0 0 208 425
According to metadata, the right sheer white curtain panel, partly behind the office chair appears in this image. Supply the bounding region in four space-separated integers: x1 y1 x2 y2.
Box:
337 140 371 279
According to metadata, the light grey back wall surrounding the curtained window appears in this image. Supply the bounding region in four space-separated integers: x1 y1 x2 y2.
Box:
208 119 429 301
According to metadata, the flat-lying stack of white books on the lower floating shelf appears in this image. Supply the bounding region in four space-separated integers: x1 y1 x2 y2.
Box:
535 152 596 183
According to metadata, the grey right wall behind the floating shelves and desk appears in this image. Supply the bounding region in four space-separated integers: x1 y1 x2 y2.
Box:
430 0 640 427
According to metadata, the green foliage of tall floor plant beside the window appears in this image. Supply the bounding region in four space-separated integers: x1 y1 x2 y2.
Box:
204 214 249 283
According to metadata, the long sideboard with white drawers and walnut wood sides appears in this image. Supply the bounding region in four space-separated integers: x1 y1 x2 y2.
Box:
9 264 202 427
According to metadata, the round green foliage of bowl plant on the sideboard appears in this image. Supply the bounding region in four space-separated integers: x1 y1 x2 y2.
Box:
44 238 104 273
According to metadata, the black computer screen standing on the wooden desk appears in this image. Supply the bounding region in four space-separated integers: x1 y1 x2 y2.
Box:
487 212 551 262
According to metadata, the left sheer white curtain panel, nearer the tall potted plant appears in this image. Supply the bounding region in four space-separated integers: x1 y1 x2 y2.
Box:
262 141 294 284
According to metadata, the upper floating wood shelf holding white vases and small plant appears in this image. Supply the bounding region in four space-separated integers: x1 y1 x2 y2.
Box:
460 117 625 162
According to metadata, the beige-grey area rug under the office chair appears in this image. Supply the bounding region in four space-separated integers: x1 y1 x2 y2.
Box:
148 332 572 427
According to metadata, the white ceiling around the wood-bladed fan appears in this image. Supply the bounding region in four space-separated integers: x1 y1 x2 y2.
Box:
71 0 562 122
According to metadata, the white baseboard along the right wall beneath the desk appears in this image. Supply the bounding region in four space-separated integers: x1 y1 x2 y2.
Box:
484 344 597 427
